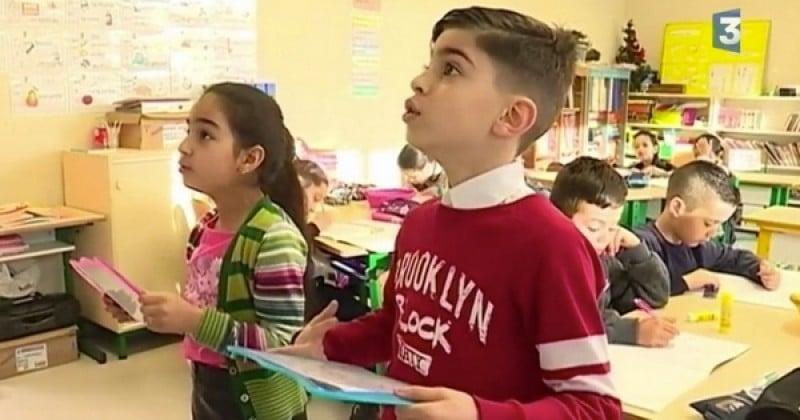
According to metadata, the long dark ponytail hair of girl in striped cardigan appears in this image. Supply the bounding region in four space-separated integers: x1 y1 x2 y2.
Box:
203 82 306 232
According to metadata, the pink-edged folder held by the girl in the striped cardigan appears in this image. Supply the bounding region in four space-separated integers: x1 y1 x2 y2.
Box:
69 257 144 322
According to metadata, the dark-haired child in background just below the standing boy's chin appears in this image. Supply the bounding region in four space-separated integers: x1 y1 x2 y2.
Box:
397 144 447 198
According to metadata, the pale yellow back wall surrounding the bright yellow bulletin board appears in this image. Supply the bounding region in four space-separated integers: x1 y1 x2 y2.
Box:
619 0 800 89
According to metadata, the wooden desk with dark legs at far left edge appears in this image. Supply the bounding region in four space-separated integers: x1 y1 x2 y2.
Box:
0 207 106 363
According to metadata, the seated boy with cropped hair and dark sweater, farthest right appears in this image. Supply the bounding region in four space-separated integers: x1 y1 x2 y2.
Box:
637 160 780 296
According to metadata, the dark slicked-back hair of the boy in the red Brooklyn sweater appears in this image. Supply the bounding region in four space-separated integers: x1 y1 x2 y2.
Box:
431 6 578 154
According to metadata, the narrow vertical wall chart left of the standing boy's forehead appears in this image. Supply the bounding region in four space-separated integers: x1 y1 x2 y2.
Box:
351 0 381 97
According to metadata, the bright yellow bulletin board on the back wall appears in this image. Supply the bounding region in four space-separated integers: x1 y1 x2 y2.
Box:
661 20 771 96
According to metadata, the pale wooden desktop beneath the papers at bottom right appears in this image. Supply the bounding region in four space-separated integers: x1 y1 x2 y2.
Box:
624 295 800 420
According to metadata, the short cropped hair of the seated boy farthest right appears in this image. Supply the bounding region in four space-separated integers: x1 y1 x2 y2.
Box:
667 160 740 210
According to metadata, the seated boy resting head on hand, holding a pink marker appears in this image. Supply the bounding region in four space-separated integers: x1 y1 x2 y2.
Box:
550 157 678 347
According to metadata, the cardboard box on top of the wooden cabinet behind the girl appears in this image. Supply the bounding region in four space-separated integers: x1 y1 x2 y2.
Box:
106 112 188 150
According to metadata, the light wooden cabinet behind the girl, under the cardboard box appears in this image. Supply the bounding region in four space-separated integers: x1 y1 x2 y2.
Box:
63 149 194 332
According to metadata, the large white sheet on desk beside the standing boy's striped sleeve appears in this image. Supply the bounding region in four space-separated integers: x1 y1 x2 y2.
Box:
609 332 750 412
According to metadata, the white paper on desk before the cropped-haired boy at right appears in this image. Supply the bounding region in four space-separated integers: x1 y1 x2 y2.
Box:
684 269 800 311
